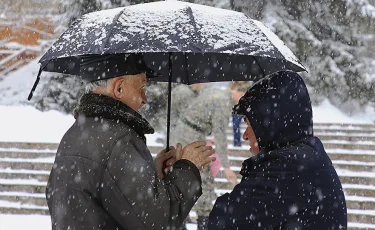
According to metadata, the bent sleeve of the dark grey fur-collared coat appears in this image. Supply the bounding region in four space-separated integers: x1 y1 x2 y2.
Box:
101 138 202 229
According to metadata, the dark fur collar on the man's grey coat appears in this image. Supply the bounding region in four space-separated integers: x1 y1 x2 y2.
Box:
74 93 154 137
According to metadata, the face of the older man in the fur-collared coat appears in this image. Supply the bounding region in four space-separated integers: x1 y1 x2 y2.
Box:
115 74 147 112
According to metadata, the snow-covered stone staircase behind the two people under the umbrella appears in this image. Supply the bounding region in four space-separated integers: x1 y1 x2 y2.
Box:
0 124 375 229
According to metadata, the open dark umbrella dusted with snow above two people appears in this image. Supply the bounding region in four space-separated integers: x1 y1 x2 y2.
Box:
29 1 305 148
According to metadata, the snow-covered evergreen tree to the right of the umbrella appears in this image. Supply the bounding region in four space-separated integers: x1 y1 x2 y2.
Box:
231 0 375 112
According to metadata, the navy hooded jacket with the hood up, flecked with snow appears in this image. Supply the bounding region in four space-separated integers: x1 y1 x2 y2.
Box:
209 71 347 230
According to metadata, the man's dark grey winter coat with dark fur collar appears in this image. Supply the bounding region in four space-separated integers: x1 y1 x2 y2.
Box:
46 94 202 230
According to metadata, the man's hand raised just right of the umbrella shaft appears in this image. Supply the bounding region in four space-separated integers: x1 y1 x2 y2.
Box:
181 141 216 170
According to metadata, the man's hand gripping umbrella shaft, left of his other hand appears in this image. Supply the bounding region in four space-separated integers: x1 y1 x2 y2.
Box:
154 146 176 180
